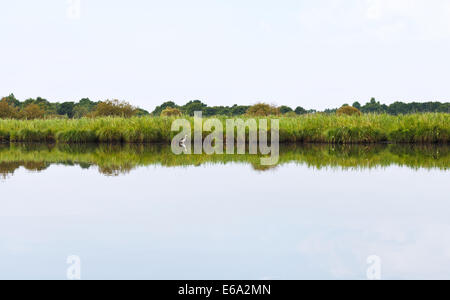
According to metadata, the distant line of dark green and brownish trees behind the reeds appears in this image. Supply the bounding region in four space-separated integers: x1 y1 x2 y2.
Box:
0 94 450 120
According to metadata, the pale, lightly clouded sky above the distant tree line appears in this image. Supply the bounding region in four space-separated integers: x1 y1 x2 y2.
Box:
0 0 450 110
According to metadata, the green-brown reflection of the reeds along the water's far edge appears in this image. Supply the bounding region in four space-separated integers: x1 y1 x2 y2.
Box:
0 144 450 177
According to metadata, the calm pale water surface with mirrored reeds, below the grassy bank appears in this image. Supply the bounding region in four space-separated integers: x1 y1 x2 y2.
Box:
0 145 450 279
